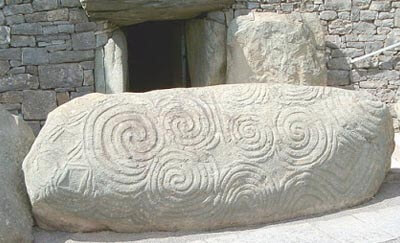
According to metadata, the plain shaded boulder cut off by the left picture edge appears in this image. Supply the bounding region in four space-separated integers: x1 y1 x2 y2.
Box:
0 106 35 243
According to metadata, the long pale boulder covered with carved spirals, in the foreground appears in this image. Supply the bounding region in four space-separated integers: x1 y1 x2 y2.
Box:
23 84 393 232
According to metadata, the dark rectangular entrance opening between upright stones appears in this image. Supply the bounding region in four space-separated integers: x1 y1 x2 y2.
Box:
124 21 189 92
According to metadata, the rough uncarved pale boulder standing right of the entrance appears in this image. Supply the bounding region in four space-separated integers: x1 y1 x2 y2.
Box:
227 12 327 85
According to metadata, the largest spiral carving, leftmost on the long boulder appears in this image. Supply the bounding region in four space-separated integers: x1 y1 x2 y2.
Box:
84 102 163 195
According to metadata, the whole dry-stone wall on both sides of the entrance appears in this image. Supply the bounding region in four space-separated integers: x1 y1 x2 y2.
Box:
0 0 400 132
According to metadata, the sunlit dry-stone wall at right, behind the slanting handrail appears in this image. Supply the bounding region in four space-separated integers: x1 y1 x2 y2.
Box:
233 0 400 130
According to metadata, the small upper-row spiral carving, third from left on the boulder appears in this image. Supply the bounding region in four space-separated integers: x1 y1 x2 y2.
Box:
230 115 275 162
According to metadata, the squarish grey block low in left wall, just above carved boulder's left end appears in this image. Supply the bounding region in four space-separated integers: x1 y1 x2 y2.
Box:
22 90 57 120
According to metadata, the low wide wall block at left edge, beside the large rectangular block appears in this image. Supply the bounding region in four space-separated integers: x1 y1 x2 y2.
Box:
0 74 39 92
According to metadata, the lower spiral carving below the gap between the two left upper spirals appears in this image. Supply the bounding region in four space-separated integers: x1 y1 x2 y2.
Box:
148 151 219 223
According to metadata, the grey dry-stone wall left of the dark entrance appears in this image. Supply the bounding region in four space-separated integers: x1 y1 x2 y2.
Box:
0 0 108 133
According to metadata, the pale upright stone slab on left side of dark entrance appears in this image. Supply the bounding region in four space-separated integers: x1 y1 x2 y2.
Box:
96 30 128 94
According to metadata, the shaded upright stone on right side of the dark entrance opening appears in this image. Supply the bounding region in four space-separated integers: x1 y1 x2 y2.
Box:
186 19 226 87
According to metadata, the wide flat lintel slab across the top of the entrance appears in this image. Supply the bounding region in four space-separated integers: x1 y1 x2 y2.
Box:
81 0 234 26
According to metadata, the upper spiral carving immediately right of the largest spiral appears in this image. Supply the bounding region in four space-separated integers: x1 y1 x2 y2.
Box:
157 96 218 149
